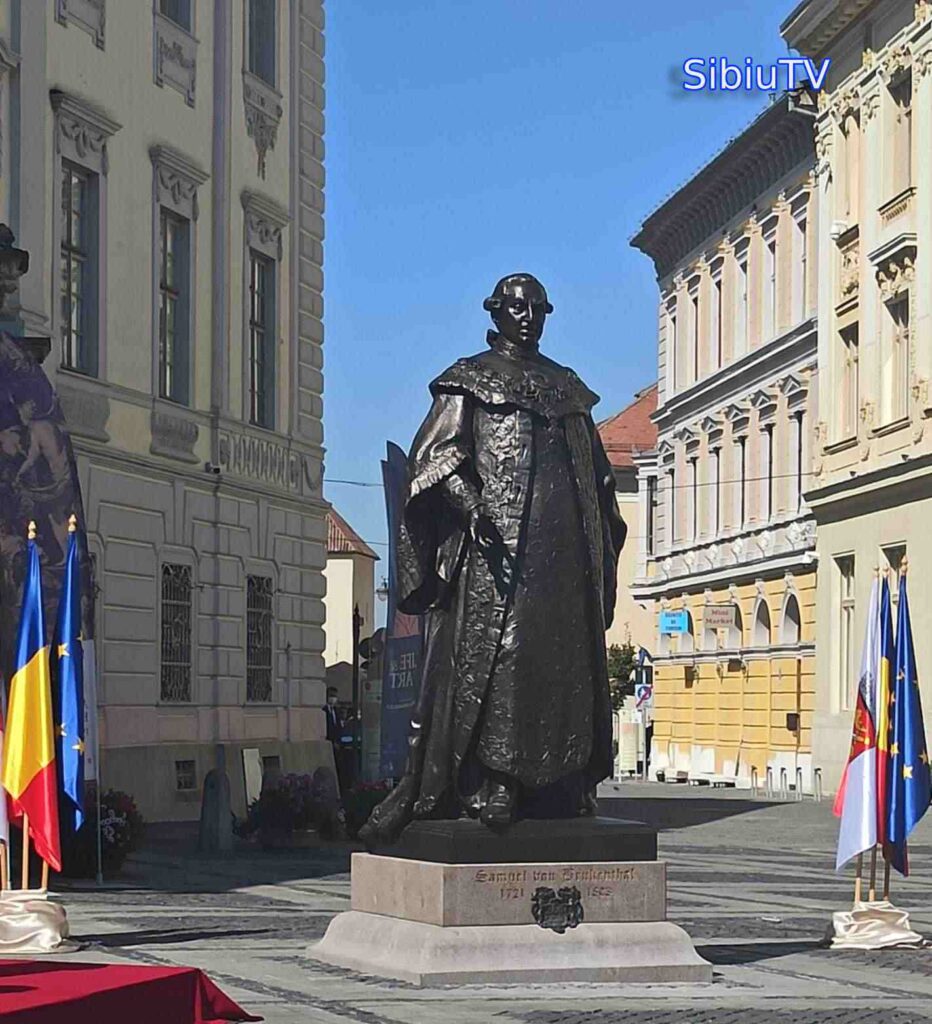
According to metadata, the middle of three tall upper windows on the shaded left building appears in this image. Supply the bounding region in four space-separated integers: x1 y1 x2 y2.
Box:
159 210 190 403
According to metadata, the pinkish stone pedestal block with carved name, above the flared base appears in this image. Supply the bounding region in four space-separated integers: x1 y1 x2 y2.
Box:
352 853 667 927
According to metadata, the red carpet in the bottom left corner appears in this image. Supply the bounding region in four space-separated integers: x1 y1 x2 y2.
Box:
0 961 262 1024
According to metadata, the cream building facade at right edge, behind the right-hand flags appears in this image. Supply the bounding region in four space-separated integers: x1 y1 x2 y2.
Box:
781 0 932 788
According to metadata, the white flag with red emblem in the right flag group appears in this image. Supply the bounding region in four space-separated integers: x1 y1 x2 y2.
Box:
833 579 882 870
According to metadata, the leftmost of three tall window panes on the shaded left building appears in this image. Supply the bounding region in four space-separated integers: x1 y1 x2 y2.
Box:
60 161 97 375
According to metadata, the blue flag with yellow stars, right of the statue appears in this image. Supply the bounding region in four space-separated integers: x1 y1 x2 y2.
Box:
887 573 932 874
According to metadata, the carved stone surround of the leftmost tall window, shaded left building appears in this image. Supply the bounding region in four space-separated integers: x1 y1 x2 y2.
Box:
49 89 122 378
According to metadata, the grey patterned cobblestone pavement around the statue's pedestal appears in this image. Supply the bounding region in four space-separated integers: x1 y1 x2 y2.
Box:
36 783 932 1024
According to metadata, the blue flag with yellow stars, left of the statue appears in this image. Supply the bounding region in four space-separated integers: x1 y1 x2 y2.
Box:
51 516 84 829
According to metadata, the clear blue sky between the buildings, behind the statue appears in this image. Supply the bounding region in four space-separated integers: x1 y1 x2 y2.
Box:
324 0 795 558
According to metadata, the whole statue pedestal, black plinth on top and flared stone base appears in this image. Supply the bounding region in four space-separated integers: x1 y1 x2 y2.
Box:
310 819 712 985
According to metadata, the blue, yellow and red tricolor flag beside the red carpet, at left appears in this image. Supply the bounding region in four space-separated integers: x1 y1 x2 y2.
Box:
0 523 61 871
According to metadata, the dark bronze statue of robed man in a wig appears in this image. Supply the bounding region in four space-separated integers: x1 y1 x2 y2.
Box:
361 273 626 846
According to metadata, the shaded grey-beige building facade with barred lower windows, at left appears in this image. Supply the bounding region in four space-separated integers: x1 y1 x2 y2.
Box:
0 0 330 819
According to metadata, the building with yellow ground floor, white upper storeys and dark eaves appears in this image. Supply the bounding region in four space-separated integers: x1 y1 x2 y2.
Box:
632 92 818 788
